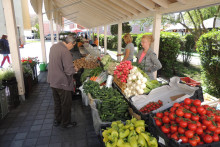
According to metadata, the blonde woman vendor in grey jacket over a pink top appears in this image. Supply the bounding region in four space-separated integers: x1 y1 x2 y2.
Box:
137 35 162 80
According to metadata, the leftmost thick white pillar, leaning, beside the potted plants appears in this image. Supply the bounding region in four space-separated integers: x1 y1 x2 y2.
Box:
2 0 25 100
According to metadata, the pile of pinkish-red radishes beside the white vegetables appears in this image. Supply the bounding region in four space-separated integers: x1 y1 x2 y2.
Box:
114 61 133 83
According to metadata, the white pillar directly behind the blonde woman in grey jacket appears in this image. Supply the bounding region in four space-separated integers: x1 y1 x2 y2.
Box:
151 13 162 78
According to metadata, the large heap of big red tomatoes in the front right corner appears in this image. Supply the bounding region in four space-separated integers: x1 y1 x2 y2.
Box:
154 98 220 146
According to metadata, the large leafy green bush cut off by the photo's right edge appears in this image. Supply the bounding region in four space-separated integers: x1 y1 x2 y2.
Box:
197 30 220 97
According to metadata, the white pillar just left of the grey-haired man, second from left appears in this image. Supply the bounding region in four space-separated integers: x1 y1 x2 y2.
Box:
37 0 47 63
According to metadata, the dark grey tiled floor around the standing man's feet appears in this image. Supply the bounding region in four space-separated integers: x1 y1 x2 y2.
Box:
0 73 101 147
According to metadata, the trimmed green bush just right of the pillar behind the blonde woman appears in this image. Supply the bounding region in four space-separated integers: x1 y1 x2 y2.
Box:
159 32 181 77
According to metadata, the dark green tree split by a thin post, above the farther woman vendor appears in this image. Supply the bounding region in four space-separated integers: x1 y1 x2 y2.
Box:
111 22 132 35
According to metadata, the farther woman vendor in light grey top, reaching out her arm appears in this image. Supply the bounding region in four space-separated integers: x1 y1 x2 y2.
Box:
117 34 134 62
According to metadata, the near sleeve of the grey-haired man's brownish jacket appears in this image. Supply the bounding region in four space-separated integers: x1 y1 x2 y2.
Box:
62 51 75 75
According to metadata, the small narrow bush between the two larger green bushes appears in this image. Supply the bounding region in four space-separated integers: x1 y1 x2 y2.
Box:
181 34 195 66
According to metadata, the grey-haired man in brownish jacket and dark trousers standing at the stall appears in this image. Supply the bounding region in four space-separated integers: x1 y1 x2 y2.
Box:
47 35 78 128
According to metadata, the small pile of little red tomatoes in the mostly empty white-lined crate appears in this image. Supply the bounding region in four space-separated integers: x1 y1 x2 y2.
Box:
140 100 163 113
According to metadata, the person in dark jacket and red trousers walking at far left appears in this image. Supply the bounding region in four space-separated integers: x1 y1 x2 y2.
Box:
0 35 11 68
